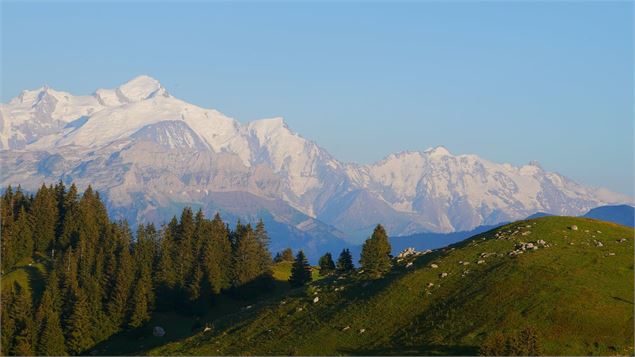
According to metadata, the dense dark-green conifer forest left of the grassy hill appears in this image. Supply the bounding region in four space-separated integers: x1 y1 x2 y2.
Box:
1 182 272 355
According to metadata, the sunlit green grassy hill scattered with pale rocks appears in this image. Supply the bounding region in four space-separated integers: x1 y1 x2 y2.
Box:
147 217 634 355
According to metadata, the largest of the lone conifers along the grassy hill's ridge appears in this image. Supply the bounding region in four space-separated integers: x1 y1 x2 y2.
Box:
359 224 391 278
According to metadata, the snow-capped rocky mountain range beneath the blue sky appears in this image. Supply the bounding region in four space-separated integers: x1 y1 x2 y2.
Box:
0 76 632 247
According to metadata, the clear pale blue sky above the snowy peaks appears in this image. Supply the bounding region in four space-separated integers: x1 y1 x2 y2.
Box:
1 1 634 195
